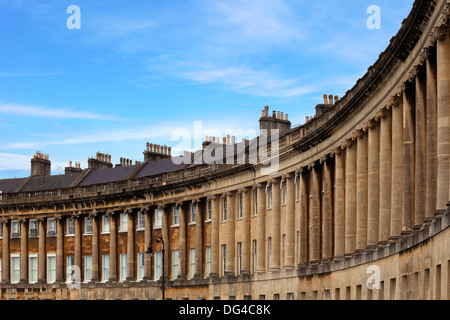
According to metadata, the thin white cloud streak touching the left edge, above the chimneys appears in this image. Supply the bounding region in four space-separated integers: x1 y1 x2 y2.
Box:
0 103 121 121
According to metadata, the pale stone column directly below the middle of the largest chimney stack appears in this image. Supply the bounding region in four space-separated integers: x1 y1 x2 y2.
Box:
269 178 281 271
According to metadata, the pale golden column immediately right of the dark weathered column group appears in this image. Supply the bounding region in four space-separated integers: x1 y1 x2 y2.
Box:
345 141 357 257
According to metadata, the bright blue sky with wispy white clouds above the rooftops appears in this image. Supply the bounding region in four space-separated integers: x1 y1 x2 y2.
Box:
0 0 413 178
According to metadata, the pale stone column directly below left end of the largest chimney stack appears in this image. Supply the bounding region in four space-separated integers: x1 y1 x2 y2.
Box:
256 183 266 273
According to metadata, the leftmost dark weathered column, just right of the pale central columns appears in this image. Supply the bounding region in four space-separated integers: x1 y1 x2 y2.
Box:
298 169 310 268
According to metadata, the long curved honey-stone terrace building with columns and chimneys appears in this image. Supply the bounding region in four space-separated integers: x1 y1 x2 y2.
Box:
0 0 450 300
